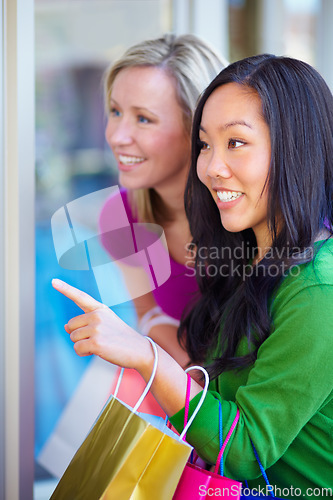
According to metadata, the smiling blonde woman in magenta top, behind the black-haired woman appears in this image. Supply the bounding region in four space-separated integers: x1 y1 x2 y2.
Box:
100 34 226 410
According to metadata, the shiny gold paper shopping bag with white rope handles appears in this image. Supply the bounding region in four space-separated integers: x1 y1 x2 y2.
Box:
51 337 208 500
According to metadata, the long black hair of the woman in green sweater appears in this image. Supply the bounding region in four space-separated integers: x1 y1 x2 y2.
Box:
179 54 333 376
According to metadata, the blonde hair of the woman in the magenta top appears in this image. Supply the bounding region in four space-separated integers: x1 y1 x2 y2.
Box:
104 34 228 222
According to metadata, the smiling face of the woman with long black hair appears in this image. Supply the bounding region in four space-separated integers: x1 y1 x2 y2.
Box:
197 83 271 252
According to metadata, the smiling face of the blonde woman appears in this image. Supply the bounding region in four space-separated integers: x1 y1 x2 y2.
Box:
105 67 190 190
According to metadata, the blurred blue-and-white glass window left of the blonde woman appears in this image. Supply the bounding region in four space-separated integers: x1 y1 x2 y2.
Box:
35 0 171 500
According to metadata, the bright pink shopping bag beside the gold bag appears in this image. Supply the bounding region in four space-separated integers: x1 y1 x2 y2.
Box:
173 366 242 500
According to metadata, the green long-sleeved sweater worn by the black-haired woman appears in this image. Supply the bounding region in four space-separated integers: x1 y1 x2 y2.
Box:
170 239 333 498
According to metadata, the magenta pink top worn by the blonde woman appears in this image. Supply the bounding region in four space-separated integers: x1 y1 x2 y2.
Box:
99 189 198 320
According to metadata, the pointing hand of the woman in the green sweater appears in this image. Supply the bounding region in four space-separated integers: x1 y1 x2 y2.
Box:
52 279 153 372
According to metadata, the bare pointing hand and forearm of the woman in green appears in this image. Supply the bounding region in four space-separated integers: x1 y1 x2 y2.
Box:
52 280 202 416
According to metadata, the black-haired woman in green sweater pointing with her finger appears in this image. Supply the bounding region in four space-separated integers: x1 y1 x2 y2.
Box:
54 55 333 492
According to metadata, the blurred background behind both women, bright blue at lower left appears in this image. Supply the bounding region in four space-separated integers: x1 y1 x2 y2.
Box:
22 0 333 500
